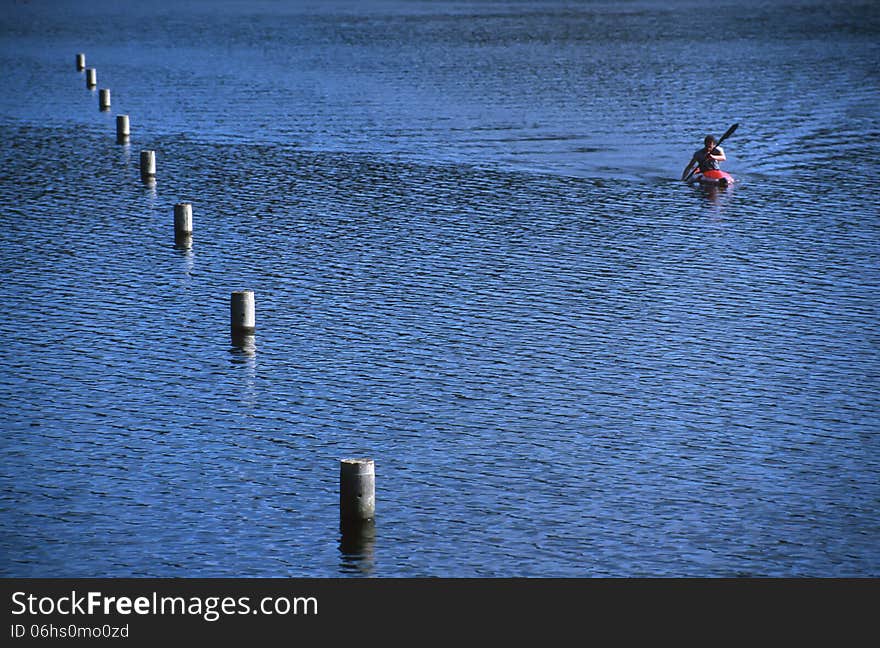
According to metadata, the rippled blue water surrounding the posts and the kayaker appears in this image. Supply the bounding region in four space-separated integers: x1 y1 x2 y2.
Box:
0 0 880 577
